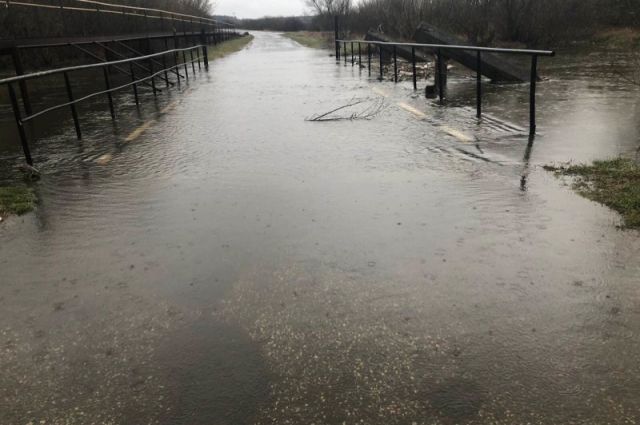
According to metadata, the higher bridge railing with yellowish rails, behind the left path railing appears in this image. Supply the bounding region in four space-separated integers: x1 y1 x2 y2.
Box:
0 0 235 36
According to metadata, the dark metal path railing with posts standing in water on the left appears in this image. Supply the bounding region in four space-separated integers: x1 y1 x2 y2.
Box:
0 45 209 165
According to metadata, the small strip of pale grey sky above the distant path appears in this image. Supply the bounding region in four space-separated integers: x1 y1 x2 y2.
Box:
214 0 307 18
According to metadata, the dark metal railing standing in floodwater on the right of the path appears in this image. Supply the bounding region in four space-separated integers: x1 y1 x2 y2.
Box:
335 38 555 135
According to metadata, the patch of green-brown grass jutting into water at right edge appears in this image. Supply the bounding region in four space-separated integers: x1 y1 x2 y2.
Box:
544 158 640 229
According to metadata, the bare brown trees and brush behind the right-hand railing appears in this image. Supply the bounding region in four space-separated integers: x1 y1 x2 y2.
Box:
307 0 640 46
